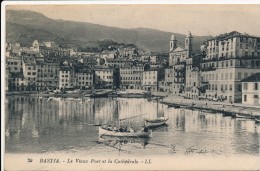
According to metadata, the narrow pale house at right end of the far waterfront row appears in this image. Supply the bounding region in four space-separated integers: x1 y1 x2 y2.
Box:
142 69 158 91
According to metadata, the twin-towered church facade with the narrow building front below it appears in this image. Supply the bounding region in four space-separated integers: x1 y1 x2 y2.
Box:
169 32 192 95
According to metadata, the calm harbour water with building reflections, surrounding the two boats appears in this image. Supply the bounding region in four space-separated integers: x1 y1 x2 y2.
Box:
5 96 260 156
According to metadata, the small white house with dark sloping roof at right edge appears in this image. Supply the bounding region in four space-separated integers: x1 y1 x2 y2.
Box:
241 73 260 106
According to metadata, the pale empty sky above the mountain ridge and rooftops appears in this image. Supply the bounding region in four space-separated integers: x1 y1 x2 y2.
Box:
6 4 260 36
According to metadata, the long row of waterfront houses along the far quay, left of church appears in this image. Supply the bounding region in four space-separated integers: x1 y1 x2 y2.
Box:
6 55 158 91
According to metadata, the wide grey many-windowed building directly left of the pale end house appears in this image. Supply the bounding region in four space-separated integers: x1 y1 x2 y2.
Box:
120 67 144 89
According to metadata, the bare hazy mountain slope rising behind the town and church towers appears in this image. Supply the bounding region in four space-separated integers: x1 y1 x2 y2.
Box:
6 10 209 52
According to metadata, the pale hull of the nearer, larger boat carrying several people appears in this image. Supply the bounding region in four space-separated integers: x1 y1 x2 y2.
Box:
99 126 152 138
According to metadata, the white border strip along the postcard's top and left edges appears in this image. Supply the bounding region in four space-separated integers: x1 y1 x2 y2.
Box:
1 0 260 170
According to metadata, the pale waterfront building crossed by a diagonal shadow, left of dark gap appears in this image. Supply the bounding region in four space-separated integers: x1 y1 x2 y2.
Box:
94 67 114 88
